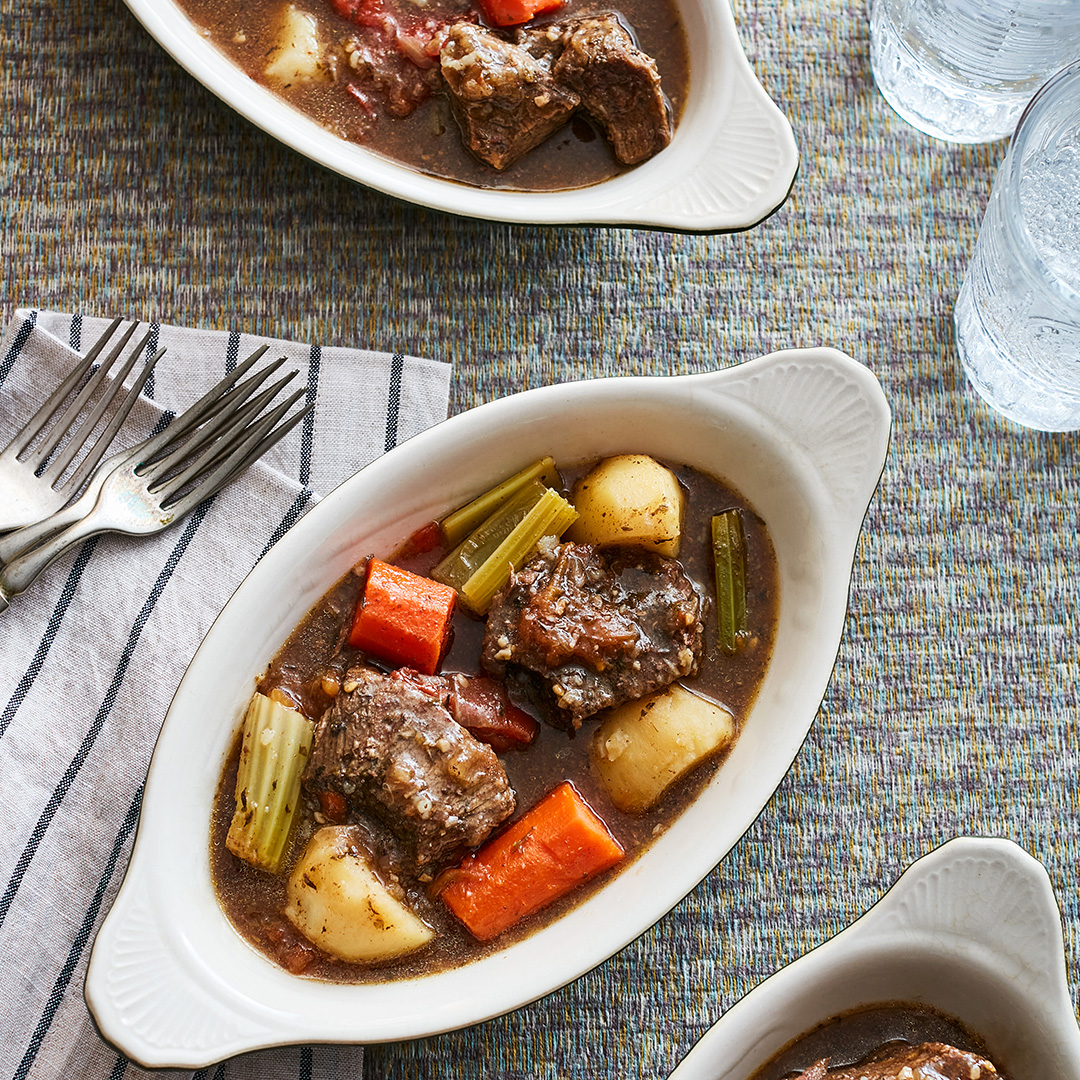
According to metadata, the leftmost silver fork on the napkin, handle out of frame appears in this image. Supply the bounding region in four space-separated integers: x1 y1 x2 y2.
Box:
0 319 165 532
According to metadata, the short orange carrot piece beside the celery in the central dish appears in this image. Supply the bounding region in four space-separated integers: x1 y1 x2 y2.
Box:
349 558 457 675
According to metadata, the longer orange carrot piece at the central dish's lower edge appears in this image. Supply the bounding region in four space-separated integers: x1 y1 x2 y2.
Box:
441 780 624 941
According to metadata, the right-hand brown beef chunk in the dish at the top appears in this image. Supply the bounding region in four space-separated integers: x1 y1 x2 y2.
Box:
553 13 672 165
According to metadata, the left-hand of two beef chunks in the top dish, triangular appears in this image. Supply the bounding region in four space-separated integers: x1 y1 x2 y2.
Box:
440 23 578 170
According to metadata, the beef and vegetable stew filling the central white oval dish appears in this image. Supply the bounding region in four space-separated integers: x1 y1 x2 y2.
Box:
211 455 779 982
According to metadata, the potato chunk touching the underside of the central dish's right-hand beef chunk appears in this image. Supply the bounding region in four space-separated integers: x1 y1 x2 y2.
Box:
592 683 735 812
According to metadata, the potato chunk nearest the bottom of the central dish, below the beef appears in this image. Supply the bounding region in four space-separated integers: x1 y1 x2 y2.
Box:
285 825 435 961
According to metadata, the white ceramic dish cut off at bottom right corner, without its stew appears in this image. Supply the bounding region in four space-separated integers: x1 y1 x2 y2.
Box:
671 837 1080 1080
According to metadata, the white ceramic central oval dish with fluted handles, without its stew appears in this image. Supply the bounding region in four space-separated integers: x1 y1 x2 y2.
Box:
86 349 890 1068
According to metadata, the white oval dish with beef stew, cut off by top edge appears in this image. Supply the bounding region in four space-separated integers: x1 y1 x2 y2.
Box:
120 0 798 225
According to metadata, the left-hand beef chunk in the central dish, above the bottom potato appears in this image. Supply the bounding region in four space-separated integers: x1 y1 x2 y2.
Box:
303 666 515 872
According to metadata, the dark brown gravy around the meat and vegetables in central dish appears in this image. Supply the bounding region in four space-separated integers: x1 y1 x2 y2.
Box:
210 462 780 983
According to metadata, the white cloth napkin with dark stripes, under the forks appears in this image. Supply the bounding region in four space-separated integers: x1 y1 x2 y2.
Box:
0 310 450 1080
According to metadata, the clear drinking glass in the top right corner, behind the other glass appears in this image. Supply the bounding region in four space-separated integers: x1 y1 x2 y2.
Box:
869 0 1080 143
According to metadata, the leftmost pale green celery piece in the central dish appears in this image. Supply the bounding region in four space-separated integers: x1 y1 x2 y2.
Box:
225 693 314 874
